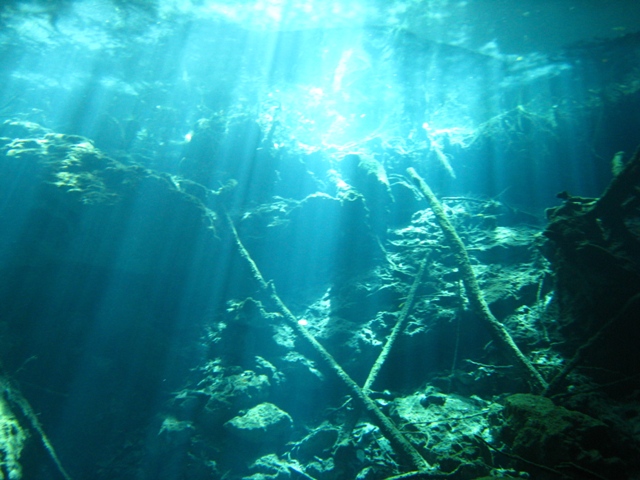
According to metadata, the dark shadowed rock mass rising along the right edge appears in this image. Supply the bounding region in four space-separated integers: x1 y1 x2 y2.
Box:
544 151 640 396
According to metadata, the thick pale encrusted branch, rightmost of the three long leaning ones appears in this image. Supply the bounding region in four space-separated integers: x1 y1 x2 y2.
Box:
407 168 547 391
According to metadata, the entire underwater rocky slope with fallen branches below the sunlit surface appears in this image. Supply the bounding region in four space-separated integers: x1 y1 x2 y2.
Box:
0 121 640 480
